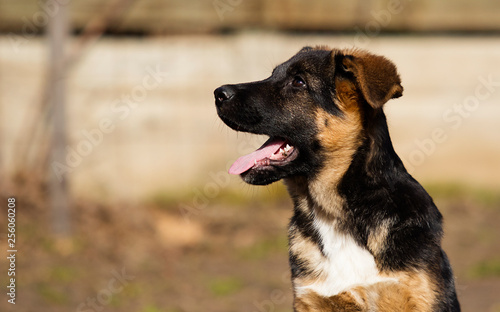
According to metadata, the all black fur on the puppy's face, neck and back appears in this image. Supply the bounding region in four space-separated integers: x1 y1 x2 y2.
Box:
215 47 460 311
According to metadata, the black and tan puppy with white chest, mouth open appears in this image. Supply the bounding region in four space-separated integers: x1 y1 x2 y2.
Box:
214 46 460 312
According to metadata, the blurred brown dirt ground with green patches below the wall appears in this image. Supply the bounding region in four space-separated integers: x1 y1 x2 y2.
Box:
0 182 500 312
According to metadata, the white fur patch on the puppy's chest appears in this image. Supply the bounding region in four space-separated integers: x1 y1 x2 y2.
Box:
295 219 396 297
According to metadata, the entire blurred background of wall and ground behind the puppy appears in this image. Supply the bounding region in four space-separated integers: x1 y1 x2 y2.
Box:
0 0 500 312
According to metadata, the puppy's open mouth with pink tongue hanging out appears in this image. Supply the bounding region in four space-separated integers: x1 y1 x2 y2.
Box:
229 137 298 174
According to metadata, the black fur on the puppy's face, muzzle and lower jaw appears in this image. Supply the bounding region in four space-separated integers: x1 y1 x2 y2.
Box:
214 49 334 185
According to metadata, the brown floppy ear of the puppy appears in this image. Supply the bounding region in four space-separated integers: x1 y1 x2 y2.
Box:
341 51 403 108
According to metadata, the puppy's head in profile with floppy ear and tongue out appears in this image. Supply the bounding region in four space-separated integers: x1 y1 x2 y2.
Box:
214 47 403 185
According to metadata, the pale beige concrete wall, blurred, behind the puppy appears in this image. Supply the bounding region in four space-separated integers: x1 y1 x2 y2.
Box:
0 33 500 198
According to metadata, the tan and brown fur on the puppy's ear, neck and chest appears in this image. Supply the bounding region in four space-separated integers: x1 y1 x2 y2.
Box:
285 47 438 312
